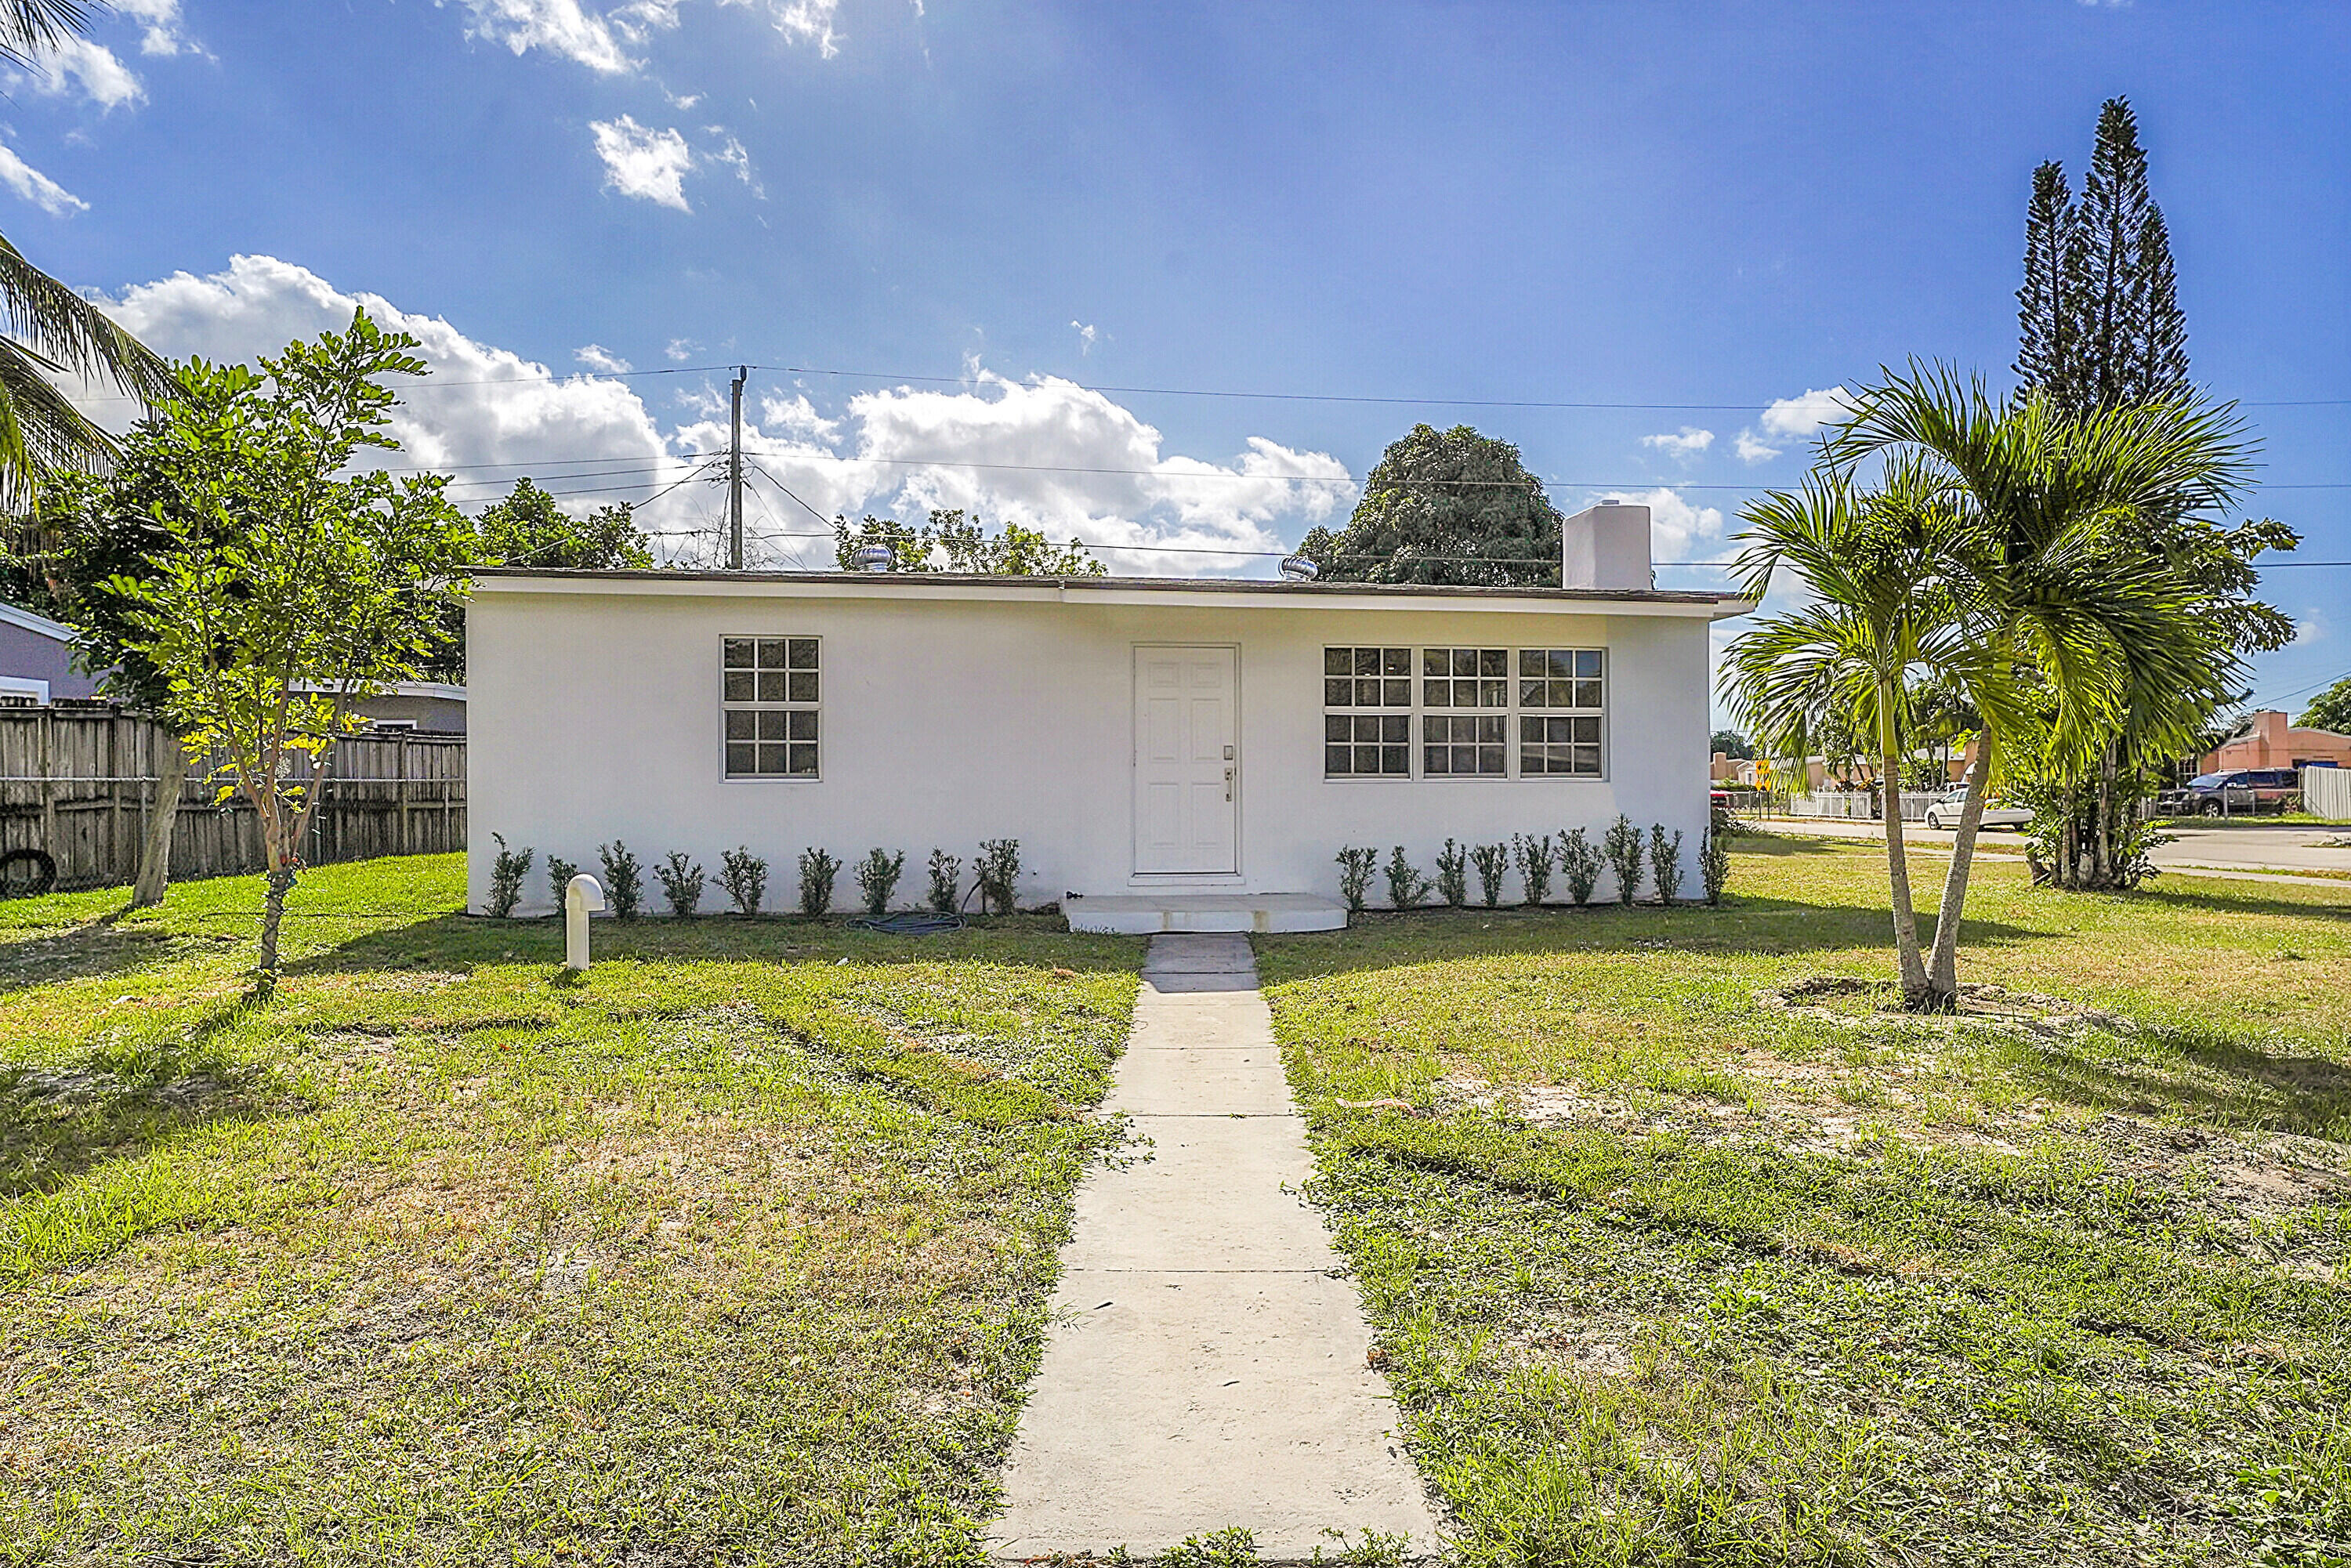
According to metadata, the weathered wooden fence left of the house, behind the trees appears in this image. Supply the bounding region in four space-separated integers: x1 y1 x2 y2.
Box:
0 705 465 889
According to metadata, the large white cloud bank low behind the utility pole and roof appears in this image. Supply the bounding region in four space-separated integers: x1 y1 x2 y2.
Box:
87 256 1364 574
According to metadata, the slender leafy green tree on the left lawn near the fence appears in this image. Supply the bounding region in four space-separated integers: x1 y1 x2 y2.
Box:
113 310 468 992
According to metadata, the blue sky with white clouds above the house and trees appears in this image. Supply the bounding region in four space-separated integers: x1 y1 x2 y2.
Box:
0 0 2351 715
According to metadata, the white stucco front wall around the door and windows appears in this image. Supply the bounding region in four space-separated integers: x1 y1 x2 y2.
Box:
468 585 1707 912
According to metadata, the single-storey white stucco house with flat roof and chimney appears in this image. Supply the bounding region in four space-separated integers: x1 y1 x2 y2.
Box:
468 505 1751 931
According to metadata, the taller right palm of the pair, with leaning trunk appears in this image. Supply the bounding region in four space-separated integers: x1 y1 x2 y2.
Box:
1822 364 2252 1006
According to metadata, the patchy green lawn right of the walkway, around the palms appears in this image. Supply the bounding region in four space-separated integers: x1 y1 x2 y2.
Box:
1260 830 2351 1566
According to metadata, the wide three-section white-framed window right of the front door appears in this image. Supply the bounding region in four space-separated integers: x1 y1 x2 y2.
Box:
1324 646 1608 778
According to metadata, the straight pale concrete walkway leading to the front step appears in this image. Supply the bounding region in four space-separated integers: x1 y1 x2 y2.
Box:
994 936 1436 1563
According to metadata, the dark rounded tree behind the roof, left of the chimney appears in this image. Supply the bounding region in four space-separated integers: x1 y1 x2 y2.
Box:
1298 425 1561 588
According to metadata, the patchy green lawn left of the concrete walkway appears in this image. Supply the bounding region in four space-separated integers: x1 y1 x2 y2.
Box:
0 858 1140 1566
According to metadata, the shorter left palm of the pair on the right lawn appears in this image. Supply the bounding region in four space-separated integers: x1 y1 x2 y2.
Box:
1726 463 1991 1009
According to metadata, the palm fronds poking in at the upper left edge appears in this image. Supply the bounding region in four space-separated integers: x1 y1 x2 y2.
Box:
0 0 169 510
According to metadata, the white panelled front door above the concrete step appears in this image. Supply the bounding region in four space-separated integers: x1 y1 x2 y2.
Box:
1136 646 1241 875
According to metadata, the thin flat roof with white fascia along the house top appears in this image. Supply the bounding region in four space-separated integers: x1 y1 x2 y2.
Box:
473 567 1754 621
